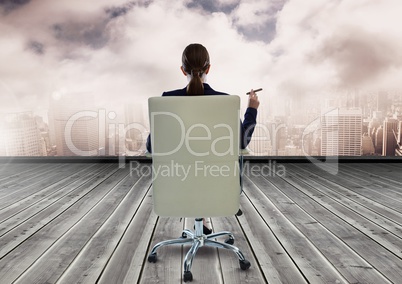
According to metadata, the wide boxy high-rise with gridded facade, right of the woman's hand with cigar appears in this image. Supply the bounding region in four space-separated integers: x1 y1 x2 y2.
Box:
321 109 362 156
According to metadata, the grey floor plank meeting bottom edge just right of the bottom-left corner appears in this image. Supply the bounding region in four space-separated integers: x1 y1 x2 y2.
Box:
12 166 138 284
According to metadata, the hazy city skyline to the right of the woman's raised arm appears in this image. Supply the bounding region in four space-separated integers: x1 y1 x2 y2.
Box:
249 91 402 156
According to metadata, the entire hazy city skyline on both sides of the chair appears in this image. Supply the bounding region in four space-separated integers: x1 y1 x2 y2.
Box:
0 91 402 156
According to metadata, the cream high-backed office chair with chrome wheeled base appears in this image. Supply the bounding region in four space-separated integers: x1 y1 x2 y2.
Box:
148 95 250 282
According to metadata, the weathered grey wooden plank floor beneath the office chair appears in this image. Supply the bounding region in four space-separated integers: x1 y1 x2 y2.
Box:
0 162 402 284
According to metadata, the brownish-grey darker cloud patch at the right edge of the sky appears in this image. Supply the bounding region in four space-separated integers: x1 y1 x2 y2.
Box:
311 27 402 88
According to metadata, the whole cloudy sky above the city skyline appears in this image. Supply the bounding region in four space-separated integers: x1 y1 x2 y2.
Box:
0 0 402 116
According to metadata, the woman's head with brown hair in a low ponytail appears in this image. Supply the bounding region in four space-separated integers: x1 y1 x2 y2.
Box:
182 43 210 95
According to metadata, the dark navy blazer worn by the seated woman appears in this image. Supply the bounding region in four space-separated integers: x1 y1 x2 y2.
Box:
146 83 257 153
